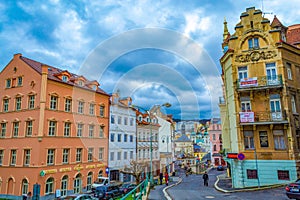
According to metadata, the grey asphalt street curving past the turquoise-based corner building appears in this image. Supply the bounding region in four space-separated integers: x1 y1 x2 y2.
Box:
167 170 289 200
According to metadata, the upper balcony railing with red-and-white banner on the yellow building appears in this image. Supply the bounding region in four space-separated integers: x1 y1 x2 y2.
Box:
237 75 282 89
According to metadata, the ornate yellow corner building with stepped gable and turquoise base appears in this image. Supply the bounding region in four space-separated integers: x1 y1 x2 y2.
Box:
220 7 300 187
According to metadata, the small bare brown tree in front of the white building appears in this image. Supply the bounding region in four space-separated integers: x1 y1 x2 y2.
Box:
120 160 148 185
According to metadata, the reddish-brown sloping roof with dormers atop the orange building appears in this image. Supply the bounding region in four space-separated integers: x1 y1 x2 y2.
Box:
20 55 110 96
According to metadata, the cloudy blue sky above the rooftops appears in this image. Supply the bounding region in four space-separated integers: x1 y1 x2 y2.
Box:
0 0 300 120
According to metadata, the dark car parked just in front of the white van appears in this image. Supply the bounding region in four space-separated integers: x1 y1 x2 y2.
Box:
93 185 123 200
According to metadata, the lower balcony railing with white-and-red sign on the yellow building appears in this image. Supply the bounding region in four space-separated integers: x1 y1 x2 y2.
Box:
239 111 287 123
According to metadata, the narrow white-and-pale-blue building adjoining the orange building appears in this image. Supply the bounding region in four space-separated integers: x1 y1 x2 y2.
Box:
108 92 136 182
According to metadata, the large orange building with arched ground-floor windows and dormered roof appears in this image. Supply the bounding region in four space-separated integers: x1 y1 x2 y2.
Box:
0 54 110 199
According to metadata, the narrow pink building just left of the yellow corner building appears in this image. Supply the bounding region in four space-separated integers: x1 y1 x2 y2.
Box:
209 118 226 167
